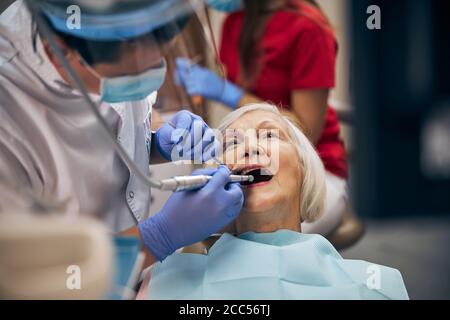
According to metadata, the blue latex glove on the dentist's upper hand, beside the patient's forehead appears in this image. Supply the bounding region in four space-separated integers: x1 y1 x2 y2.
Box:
155 111 220 164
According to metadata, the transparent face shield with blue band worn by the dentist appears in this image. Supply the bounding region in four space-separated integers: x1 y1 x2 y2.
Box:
28 0 223 108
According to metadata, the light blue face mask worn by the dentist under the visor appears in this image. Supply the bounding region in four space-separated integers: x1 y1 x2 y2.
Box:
85 59 167 103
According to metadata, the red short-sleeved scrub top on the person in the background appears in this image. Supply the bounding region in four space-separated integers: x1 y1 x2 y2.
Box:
220 3 348 178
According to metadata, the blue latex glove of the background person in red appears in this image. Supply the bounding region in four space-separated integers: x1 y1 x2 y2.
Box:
175 58 244 109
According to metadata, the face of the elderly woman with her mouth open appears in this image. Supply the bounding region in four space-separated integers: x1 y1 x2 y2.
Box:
223 110 303 215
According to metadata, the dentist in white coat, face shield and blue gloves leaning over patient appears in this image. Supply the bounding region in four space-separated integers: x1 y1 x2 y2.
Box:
0 0 243 263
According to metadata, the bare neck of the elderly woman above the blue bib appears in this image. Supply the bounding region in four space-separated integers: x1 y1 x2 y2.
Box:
235 202 301 234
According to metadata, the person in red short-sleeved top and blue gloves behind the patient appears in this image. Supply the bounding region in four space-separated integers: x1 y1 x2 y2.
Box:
177 0 348 235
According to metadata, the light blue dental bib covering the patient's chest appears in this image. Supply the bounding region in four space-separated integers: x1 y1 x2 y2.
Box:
148 230 408 300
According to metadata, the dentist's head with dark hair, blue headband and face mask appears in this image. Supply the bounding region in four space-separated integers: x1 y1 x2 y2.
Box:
30 0 192 102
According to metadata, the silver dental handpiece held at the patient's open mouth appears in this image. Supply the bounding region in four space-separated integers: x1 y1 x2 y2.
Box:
160 174 254 192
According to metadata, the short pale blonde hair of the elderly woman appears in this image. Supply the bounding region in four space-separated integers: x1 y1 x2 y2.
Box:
218 103 326 222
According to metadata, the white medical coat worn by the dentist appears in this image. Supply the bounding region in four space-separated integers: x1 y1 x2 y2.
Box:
0 1 156 231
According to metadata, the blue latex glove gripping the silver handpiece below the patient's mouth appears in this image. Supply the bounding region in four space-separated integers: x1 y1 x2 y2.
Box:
138 166 244 261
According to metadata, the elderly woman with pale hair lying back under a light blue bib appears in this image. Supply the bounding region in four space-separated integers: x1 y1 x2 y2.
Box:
140 104 408 299
